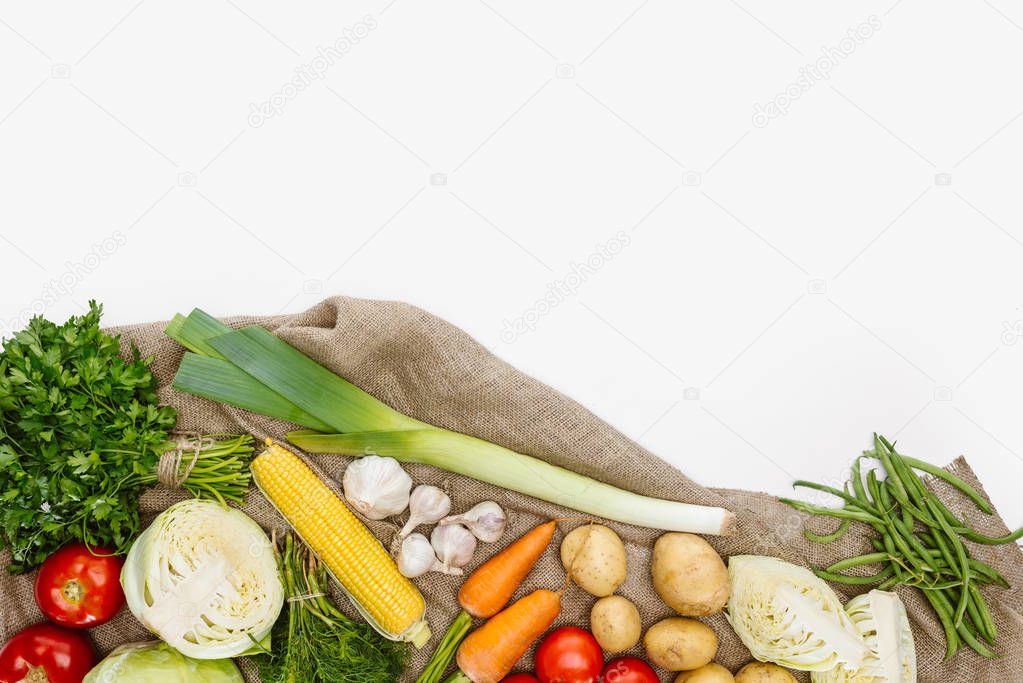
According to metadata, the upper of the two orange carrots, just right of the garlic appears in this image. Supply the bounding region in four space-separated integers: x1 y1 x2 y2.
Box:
458 520 558 618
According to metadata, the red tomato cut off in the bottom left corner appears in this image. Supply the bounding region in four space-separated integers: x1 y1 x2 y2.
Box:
0 623 96 683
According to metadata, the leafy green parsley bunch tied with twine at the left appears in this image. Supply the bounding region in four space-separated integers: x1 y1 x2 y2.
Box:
0 302 252 573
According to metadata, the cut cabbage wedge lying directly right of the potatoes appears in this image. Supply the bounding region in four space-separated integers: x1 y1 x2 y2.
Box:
725 555 868 671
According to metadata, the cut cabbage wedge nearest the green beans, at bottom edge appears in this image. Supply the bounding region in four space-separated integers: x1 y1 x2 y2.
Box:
810 591 917 683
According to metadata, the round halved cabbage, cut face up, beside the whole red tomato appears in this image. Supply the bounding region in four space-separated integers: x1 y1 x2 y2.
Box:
121 500 284 659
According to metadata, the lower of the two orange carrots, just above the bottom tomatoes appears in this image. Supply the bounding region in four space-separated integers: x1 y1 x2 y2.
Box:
457 589 562 683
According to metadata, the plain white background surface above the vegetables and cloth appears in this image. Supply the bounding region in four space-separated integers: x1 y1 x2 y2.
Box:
0 0 1023 526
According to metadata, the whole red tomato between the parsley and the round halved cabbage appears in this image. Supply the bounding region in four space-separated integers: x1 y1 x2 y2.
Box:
36 543 125 629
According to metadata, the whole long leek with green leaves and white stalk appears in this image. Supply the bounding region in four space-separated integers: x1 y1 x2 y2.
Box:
167 309 735 534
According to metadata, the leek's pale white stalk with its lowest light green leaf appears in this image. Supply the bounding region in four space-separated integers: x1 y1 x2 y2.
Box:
287 428 735 535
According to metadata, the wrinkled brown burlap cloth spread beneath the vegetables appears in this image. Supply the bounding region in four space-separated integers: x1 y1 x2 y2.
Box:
0 298 1023 683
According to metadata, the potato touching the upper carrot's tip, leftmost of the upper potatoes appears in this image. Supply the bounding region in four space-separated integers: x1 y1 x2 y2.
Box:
562 525 626 597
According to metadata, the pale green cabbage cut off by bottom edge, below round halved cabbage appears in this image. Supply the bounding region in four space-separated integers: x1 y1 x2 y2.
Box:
82 642 244 683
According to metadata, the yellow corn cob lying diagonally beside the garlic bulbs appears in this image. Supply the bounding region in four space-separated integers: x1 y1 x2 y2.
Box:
252 439 430 647
